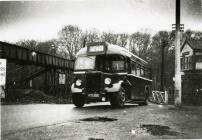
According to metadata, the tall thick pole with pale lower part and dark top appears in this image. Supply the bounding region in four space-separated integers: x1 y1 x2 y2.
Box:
174 0 182 106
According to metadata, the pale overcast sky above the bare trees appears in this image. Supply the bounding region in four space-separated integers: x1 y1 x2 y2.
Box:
0 0 202 42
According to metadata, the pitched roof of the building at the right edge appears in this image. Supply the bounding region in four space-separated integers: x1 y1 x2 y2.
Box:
180 40 202 51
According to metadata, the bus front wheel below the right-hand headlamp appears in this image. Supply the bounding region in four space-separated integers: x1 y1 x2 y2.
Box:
110 88 126 108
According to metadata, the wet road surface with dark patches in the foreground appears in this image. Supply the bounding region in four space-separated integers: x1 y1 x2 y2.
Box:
1 103 202 140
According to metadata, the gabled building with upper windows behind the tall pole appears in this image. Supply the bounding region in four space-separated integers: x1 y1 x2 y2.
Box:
181 40 202 105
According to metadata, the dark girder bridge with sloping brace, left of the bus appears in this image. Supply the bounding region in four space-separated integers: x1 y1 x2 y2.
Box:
0 41 74 97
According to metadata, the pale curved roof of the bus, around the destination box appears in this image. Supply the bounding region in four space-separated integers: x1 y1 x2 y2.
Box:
76 42 147 64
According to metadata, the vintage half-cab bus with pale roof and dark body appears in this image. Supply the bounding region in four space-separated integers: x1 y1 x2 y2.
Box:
71 42 152 108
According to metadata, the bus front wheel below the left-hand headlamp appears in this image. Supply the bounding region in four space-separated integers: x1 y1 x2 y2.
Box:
72 94 85 107
